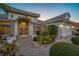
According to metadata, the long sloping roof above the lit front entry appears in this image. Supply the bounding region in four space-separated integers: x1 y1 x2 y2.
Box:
0 4 40 18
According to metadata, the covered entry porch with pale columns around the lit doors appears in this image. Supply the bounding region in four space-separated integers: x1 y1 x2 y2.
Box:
14 17 36 36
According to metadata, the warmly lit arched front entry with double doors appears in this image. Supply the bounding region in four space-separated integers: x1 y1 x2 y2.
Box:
18 19 29 35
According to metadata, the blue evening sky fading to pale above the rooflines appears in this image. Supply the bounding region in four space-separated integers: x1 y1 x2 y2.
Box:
9 3 79 22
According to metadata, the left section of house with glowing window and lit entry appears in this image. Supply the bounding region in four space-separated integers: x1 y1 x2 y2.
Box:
0 4 40 42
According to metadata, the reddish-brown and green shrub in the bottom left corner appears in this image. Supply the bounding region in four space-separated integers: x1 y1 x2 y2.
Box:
0 43 18 56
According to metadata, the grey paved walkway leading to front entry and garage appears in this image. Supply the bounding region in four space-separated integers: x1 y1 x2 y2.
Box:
17 37 70 56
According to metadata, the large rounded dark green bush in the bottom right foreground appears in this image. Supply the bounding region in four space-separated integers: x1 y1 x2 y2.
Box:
49 42 79 56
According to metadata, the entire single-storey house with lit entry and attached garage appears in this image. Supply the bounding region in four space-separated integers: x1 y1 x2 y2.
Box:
0 4 72 42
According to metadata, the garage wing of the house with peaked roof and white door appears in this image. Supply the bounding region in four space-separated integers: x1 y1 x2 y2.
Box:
36 12 73 38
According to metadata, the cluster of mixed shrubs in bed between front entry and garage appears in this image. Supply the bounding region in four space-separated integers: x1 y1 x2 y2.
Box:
33 25 58 45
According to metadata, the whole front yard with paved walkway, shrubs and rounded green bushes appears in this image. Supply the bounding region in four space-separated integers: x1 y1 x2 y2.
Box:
0 26 79 56
